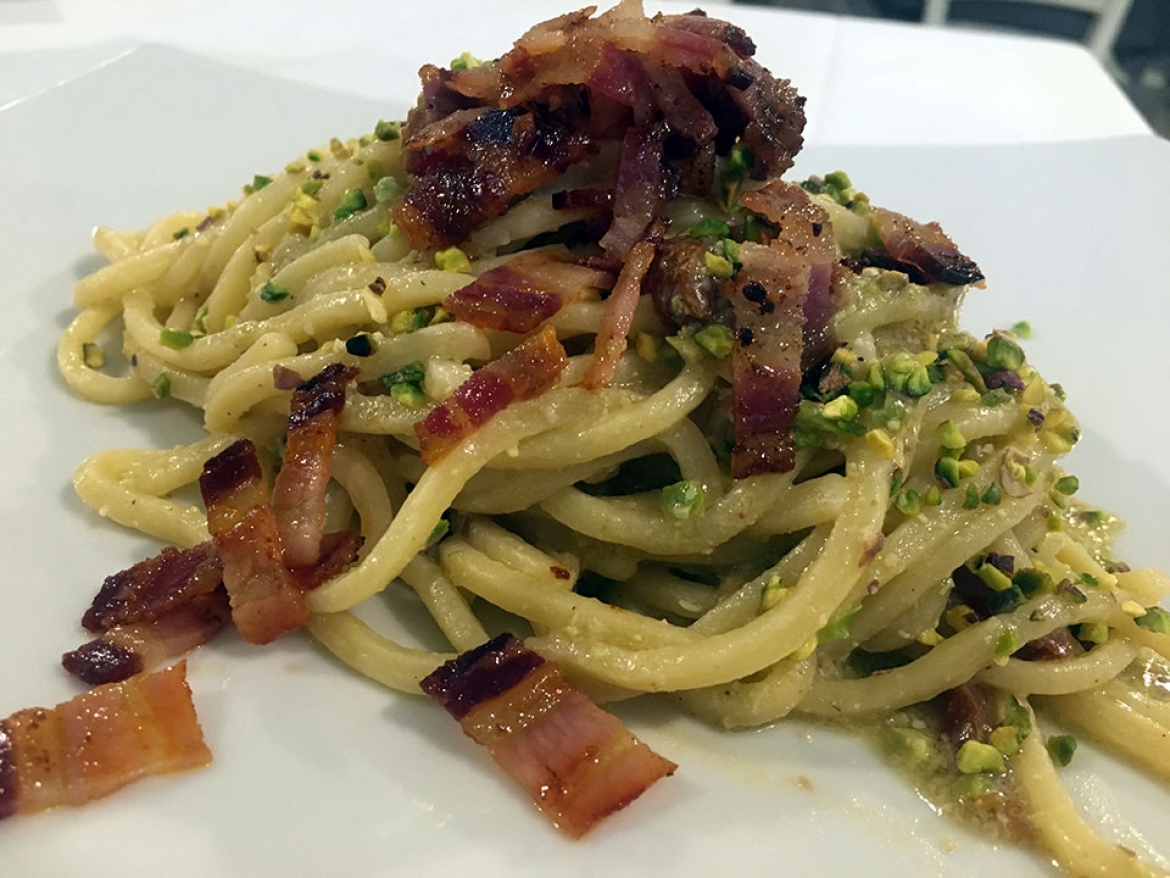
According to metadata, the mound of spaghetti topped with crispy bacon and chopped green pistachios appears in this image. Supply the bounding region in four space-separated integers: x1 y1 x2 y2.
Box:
57 4 1170 874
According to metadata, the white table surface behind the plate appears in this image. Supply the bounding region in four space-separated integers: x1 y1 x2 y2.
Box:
0 0 1150 145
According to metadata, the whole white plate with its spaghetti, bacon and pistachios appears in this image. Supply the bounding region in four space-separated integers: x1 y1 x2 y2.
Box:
0 2 1170 876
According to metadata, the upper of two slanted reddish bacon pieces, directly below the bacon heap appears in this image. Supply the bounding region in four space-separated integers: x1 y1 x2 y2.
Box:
443 253 613 332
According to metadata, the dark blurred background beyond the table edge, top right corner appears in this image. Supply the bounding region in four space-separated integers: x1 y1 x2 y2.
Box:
736 0 1170 137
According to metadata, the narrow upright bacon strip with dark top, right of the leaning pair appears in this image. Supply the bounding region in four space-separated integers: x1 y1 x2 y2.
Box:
271 363 357 567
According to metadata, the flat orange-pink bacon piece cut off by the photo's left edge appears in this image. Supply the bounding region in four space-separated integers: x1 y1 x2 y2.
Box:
0 663 212 818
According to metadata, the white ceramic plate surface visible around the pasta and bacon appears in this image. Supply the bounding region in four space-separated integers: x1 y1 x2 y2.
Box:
0 49 1170 878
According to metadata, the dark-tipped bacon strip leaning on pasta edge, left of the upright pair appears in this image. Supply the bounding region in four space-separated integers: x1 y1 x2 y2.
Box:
199 439 309 644
